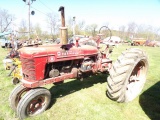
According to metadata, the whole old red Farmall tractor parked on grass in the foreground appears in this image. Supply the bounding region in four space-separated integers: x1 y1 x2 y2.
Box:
9 7 148 119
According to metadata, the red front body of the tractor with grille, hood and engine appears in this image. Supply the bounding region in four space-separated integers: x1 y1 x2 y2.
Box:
20 44 100 87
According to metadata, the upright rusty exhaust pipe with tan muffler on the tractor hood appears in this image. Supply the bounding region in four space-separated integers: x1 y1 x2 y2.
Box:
58 6 68 45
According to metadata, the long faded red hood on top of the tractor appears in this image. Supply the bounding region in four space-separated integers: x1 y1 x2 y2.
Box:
19 44 98 58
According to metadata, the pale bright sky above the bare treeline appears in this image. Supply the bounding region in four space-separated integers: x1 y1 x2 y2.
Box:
0 0 160 30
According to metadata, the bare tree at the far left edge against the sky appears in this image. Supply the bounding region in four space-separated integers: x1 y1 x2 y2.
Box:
0 9 14 32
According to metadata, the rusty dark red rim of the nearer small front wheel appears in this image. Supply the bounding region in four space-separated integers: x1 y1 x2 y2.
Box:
27 95 47 116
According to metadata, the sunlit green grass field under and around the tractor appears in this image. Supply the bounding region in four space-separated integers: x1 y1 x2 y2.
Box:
0 46 160 120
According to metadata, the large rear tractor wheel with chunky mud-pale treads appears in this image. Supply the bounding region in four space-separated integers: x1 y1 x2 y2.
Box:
107 48 149 102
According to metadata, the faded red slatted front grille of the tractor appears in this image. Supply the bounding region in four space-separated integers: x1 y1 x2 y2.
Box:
21 58 36 80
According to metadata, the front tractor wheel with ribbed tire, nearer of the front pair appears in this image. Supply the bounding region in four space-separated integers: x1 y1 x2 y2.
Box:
17 88 51 119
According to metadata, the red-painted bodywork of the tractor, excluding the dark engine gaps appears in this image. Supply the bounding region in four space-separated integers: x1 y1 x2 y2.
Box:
20 40 112 88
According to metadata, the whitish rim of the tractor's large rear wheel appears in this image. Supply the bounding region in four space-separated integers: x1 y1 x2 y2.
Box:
125 61 146 101
